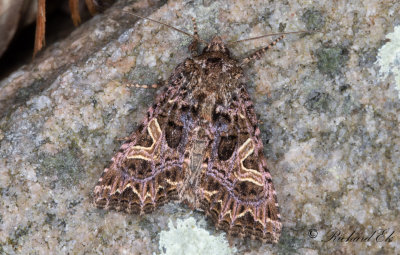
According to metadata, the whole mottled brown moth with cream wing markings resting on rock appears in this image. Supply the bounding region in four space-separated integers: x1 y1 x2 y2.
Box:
94 15 304 243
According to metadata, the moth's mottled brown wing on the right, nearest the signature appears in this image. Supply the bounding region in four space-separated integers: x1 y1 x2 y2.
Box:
197 86 282 242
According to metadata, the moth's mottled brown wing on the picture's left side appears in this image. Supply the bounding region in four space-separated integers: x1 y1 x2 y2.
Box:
94 67 187 214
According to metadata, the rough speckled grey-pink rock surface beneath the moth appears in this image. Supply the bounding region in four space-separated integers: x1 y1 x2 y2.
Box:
0 0 400 254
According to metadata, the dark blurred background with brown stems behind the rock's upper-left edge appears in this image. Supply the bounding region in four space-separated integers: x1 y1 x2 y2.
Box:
0 0 115 80
